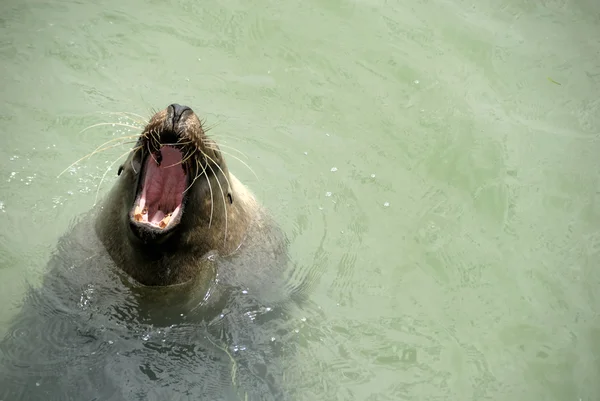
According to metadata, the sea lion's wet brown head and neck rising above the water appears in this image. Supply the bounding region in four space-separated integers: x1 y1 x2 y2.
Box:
96 104 281 286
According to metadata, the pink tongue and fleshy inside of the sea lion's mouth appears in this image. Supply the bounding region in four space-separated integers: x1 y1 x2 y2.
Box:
140 146 186 224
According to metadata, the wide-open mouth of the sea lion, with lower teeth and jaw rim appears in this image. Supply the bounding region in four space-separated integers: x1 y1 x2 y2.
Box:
131 145 188 231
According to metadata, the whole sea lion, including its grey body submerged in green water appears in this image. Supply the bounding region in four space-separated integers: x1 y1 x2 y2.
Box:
0 104 293 400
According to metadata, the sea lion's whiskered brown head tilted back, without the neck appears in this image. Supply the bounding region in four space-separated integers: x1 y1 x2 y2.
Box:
118 104 234 248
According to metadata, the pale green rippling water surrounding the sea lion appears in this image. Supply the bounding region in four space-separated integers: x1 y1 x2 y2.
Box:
0 0 600 401
